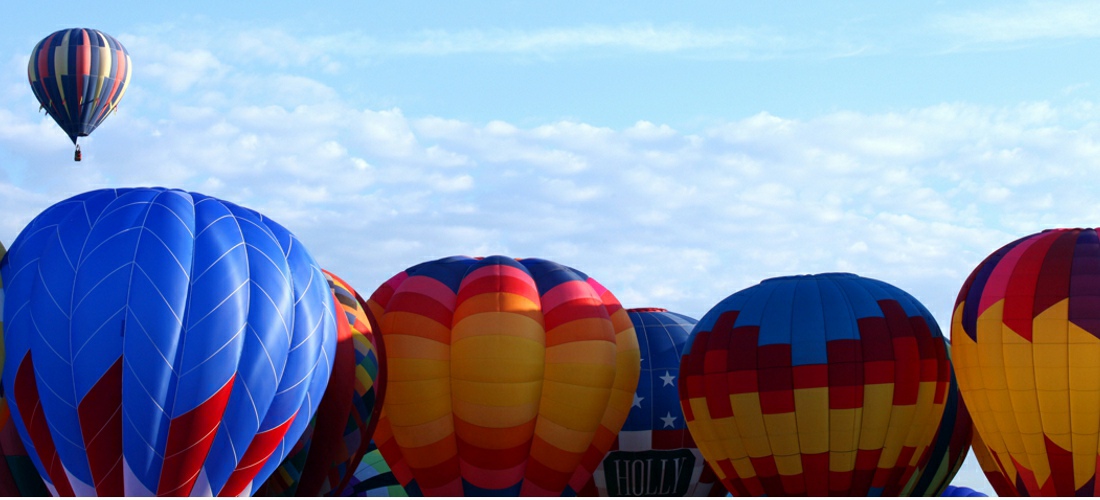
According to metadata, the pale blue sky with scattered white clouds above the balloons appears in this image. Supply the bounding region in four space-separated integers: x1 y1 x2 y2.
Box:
0 0 1100 492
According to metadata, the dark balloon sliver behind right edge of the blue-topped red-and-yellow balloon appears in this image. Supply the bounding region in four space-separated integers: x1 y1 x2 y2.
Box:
910 343 974 497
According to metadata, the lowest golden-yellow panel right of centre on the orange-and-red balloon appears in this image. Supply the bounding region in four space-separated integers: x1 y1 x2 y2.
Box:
539 380 614 430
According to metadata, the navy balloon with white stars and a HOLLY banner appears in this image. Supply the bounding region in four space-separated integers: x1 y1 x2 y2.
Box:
579 308 726 497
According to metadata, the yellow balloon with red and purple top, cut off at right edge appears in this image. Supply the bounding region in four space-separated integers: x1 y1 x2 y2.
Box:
952 229 1100 497
